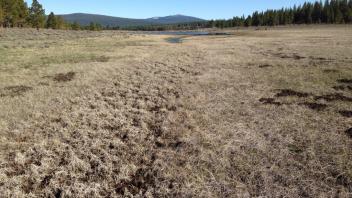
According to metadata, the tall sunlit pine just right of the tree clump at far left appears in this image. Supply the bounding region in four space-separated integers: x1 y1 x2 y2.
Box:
29 0 45 30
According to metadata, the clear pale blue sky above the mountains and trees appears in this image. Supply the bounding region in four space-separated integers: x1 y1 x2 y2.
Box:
27 0 314 19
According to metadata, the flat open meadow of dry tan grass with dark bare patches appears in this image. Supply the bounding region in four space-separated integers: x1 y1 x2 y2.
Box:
0 26 352 197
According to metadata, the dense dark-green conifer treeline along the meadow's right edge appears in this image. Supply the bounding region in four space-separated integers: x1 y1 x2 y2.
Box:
208 0 352 28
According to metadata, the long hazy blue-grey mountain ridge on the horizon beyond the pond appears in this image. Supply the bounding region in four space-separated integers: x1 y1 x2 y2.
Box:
60 13 205 27
